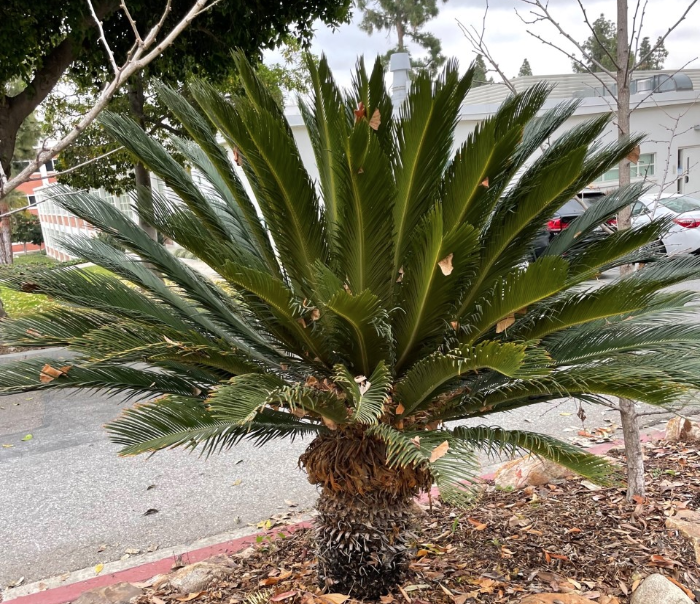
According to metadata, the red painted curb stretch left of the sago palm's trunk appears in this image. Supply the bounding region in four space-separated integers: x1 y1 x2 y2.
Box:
6 521 311 604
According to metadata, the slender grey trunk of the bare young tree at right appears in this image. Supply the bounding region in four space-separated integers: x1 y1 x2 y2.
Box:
616 0 645 501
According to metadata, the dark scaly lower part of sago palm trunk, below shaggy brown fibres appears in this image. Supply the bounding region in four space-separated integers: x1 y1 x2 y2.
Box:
315 493 414 600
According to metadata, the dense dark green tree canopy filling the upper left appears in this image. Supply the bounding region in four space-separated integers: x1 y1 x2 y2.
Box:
0 0 349 179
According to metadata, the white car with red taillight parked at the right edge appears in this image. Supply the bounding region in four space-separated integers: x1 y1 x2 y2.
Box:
632 194 700 254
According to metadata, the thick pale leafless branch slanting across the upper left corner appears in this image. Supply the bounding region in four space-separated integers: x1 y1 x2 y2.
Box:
0 0 213 199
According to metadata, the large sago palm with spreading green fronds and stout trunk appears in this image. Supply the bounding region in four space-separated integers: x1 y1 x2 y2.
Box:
0 56 700 598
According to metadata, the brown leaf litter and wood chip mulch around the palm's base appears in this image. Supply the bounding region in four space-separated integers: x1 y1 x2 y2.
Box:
137 442 700 604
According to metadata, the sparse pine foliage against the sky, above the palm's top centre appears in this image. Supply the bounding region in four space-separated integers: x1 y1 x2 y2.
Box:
357 0 447 75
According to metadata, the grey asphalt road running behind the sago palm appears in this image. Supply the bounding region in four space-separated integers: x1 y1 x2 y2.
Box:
0 272 700 587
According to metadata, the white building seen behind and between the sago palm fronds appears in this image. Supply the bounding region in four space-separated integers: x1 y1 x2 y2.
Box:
37 64 700 260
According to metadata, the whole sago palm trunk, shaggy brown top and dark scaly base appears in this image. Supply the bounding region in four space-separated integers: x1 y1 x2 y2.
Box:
299 427 432 600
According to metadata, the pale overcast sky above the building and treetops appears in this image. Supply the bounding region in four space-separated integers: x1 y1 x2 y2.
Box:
267 0 700 86
